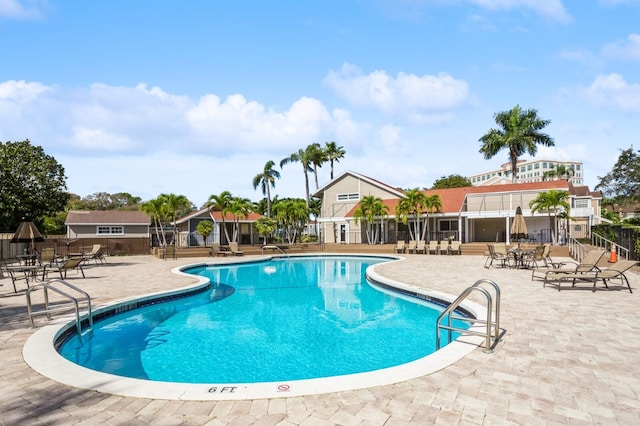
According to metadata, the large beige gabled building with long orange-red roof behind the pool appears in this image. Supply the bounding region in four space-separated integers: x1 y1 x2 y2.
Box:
313 171 602 244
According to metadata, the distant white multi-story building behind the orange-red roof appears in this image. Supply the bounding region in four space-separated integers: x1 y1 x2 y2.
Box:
469 160 584 186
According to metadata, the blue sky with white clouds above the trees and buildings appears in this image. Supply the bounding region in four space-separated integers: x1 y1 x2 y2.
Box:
0 0 640 206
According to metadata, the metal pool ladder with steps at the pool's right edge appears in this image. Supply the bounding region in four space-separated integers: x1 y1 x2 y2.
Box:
436 279 506 353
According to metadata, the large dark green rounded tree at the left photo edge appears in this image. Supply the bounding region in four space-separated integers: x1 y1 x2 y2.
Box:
0 139 70 232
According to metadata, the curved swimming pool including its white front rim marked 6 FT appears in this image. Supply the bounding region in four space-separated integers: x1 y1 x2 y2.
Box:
24 256 484 399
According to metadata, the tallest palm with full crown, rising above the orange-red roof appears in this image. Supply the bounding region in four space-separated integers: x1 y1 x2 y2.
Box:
480 105 555 183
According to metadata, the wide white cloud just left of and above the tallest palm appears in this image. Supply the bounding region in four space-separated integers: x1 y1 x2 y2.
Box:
325 63 469 117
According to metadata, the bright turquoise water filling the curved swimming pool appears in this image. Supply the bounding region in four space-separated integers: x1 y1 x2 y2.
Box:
58 257 464 383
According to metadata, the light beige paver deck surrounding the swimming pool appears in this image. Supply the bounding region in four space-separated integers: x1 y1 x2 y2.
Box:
0 255 640 426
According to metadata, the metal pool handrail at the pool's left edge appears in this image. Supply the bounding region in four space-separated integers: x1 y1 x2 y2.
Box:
27 278 93 337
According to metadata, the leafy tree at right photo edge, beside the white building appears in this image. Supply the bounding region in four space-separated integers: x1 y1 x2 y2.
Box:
595 146 640 205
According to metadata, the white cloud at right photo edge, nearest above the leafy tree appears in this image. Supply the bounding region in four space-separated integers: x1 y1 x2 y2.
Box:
582 74 640 112
